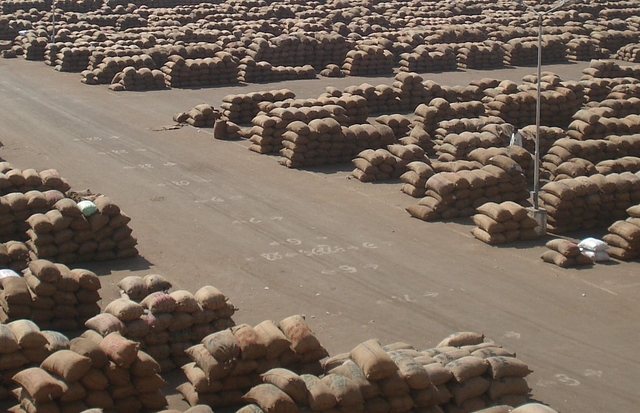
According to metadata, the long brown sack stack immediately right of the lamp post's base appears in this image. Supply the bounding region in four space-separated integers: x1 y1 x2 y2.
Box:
539 172 640 234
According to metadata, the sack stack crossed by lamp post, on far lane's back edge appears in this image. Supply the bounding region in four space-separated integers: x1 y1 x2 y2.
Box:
503 35 567 66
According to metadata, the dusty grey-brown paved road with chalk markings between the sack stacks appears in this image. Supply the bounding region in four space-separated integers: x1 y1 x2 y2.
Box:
0 60 640 413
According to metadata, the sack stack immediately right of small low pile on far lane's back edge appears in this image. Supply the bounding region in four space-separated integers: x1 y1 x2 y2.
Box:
160 51 238 87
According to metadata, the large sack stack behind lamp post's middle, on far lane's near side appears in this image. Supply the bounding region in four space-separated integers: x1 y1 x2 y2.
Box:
482 72 583 127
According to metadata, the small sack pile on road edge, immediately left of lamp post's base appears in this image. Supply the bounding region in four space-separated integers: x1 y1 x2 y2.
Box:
471 201 540 245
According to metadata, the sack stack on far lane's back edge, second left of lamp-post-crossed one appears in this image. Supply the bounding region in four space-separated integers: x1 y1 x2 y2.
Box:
398 44 458 73
